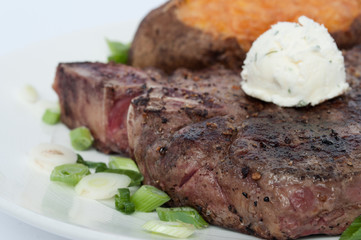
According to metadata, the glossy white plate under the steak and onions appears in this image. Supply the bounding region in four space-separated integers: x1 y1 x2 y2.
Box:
0 22 338 240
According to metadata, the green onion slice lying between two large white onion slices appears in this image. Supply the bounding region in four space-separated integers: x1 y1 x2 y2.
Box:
50 163 90 186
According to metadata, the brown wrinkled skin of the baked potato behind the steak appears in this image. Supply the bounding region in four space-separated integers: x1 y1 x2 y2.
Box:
129 0 361 73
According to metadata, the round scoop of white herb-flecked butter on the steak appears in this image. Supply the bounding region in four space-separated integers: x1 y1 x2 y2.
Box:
241 16 349 107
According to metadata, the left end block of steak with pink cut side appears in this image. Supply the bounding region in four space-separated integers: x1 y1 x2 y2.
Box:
53 62 150 154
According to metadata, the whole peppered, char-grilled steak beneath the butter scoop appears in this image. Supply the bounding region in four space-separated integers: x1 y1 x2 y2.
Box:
54 47 361 239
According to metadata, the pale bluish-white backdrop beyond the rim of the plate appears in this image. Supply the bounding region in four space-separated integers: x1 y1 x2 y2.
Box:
0 0 165 240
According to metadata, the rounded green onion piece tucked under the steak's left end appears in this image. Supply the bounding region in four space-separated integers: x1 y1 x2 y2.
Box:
70 127 94 151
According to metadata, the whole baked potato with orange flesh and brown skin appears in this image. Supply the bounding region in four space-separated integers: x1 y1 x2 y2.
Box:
129 0 361 72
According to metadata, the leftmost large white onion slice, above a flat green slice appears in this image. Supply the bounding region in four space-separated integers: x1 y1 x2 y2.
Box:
29 143 77 174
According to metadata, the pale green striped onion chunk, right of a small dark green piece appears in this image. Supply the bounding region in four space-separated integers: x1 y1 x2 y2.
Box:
130 185 170 212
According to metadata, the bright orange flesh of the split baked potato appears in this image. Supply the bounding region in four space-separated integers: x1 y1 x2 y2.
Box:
176 0 361 51
